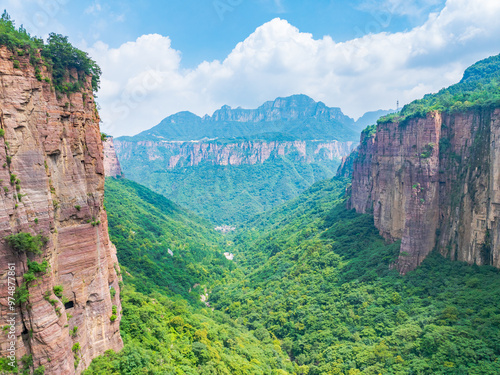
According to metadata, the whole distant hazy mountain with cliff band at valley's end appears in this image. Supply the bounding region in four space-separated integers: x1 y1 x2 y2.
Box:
113 95 391 225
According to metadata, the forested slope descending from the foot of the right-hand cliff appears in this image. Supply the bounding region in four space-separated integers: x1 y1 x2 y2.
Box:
211 179 500 374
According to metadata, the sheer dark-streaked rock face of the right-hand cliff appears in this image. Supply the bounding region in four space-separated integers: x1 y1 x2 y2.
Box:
348 109 500 273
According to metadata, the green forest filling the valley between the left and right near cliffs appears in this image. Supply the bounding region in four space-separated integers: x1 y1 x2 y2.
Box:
85 177 500 375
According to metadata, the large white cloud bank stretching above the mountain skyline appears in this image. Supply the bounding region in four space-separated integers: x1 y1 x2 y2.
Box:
90 0 500 135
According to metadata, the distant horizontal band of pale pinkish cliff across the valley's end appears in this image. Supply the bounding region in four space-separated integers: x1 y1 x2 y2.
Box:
115 140 353 169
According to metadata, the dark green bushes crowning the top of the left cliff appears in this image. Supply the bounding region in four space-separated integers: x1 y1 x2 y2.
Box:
0 11 101 93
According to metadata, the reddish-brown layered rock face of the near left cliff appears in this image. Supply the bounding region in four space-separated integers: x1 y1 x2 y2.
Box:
0 47 123 374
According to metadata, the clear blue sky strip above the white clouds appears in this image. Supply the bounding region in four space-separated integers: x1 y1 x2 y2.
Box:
8 0 445 68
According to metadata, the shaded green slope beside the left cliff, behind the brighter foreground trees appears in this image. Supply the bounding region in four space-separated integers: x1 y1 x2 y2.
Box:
104 178 233 299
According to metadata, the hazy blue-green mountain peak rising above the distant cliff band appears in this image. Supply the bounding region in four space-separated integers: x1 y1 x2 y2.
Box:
122 95 357 141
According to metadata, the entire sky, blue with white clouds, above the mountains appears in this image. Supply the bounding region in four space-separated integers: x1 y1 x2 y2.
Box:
2 0 500 136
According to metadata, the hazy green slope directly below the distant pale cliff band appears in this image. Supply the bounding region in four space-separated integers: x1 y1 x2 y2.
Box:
122 156 339 225
